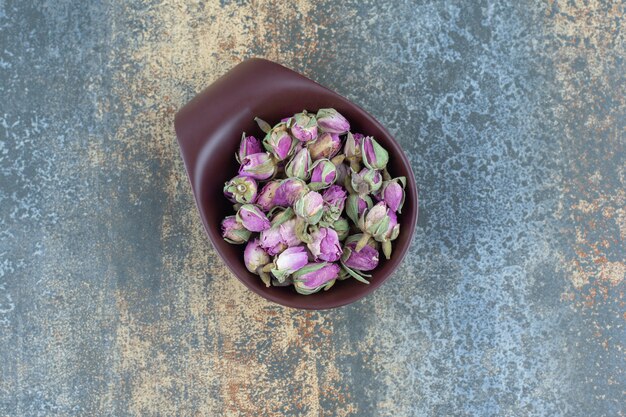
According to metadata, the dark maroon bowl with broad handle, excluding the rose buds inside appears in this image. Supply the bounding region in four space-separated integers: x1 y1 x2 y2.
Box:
174 59 418 310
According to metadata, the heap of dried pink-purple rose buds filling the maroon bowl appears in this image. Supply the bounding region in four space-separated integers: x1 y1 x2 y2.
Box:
222 109 406 294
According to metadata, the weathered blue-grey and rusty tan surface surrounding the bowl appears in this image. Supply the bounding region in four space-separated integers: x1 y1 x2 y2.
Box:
0 0 626 416
